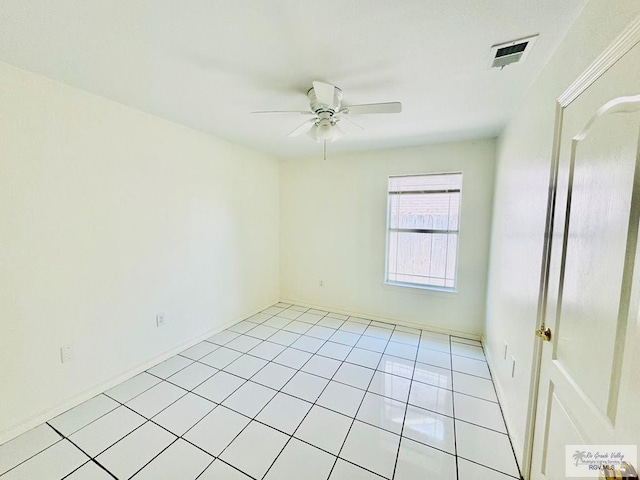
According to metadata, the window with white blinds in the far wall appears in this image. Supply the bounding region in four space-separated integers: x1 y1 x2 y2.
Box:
386 173 462 290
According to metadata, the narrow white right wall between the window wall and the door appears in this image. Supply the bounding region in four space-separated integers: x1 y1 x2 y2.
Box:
485 0 640 461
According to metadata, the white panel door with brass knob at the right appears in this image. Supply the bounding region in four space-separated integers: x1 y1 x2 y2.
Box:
531 17 640 480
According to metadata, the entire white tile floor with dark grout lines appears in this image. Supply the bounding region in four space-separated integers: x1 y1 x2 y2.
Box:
0 303 520 480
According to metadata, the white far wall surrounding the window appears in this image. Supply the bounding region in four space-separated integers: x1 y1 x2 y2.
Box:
280 139 495 334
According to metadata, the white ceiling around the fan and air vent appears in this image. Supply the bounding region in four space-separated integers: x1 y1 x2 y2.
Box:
0 0 586 157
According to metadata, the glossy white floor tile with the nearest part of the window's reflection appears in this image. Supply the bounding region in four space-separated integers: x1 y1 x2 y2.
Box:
402 405 458 455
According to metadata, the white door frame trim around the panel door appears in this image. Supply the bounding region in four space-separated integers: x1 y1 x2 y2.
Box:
522 15 640 479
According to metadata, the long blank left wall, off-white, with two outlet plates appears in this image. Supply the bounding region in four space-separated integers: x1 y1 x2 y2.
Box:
0 64 279 443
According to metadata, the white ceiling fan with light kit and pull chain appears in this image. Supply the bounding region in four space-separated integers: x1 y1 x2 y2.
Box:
252 81 402 145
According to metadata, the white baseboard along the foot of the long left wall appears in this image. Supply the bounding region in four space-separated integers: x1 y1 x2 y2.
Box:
0 301 278 445
